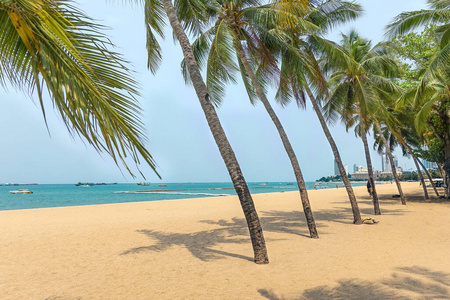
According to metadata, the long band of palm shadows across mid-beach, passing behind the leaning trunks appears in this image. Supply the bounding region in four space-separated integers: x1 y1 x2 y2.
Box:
122 202 412 261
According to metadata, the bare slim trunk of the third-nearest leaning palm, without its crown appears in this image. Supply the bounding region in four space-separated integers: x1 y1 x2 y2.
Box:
305 86 362 224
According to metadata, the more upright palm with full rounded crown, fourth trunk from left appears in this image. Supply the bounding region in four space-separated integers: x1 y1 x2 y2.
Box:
324 31 397 215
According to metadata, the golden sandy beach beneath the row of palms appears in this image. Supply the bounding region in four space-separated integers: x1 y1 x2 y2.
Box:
0 183 450 299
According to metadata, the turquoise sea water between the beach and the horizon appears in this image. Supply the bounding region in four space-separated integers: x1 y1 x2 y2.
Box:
0 182 364 210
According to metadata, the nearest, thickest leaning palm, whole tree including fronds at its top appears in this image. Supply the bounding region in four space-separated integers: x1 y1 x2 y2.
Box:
145 0 269 264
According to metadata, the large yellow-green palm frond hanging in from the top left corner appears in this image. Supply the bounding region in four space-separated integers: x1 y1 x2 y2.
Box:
0 0 159 176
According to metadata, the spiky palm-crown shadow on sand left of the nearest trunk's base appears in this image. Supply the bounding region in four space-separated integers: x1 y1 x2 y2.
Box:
121 224 254 261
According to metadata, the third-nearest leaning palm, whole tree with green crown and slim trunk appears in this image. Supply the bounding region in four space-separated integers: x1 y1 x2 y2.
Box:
269 0 362 224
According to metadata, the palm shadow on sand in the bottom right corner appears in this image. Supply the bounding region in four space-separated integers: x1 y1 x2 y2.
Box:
258 266 450 300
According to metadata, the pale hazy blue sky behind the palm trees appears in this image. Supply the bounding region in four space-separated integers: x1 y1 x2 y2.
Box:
0 0 426 184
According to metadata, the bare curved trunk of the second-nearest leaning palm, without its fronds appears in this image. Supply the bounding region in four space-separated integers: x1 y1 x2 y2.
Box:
236 40 319 238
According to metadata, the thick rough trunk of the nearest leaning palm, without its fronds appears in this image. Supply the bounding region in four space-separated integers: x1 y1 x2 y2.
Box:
162 0 269 264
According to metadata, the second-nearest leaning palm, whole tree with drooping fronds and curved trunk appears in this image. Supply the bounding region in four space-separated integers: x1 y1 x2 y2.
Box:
183 0 318 238
